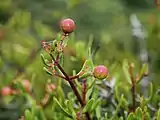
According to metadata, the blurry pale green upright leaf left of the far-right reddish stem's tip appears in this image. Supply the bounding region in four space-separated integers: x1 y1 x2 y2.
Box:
123 59 131 84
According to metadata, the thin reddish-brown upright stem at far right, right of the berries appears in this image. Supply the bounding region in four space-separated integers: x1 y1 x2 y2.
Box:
129 64 136 112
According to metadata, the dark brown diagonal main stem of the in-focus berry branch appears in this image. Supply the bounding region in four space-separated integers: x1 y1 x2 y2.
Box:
49 53 92 120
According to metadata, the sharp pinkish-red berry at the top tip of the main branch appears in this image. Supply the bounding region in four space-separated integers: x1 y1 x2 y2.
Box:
60 18 75 34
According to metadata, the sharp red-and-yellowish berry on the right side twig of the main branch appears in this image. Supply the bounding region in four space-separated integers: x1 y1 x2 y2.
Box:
93 65 108 80
